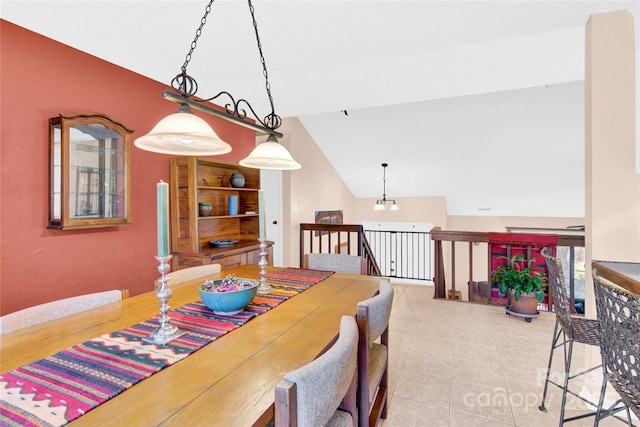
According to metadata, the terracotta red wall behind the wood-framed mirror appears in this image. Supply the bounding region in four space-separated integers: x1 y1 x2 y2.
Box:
0 20 255 314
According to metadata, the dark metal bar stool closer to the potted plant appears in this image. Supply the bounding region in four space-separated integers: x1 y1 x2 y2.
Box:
538 248 602 426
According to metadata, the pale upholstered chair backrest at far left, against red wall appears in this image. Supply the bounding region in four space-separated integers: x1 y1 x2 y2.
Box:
0 289 129 335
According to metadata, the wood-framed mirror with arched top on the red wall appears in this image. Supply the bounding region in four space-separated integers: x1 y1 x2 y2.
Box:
48 114 133 229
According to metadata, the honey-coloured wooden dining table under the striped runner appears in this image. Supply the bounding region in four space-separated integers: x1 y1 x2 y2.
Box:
0 265 380 427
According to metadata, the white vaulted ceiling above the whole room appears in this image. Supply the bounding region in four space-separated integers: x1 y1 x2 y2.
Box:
0 0 640 217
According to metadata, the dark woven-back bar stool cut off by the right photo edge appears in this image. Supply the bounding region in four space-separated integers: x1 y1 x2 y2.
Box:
593 270 640 427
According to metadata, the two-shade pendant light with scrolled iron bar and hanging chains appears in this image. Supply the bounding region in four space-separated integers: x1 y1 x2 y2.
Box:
134 0 301 170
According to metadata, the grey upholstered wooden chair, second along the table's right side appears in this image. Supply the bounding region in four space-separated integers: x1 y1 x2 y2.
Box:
356 279 393 427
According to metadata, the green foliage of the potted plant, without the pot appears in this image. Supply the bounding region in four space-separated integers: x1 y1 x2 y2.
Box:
491 254 548 302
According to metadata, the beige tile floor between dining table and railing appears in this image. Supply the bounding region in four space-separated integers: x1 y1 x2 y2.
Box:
382 284 638 427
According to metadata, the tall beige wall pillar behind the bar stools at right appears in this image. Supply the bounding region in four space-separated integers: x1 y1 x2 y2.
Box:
585 10 640 317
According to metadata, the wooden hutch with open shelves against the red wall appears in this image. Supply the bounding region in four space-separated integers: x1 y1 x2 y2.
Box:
169 157 272 270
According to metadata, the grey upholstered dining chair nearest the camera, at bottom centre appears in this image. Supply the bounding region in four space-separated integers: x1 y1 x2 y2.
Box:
275 316 358 427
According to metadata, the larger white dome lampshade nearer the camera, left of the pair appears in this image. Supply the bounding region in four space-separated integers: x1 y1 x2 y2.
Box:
133 104 231 156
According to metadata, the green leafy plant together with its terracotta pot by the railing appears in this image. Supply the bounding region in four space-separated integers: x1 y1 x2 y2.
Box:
491 254 548 314
